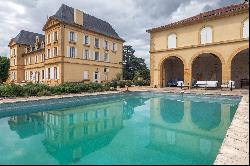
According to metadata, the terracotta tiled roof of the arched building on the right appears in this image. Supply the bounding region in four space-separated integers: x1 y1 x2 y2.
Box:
147 2 249 33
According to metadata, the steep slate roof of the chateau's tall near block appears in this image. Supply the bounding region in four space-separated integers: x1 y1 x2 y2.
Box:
52 4 124 41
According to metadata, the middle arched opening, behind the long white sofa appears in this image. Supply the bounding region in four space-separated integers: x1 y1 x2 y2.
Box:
192 53 222 85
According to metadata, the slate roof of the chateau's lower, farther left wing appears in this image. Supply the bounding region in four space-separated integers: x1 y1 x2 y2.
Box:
11 30 45 46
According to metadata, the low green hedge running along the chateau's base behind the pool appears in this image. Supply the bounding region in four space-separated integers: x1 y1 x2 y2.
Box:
0 80 149 97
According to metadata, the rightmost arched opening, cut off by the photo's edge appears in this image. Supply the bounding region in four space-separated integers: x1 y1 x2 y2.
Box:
231 49 249 88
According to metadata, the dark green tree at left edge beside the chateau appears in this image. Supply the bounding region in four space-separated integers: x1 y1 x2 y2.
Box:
0 56 10 83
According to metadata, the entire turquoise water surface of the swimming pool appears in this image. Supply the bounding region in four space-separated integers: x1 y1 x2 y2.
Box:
0 92 240 164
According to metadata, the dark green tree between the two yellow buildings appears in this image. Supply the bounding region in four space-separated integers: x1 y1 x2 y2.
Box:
123 45 150 80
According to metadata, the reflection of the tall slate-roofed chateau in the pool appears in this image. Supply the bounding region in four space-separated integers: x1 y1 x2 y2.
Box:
9 97 147 164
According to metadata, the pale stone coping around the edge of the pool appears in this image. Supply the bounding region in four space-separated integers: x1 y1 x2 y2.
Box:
0 87 249 165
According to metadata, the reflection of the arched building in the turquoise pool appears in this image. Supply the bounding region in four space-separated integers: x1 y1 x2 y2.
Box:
148 98 235 163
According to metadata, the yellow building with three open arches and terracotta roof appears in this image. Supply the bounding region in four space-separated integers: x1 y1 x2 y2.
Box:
147 2 249 88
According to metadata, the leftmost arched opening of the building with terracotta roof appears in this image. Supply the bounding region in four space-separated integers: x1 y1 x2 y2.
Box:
162 56 184 87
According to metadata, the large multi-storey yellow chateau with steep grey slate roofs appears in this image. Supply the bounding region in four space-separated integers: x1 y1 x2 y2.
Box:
8 4 124 85
